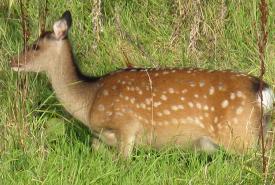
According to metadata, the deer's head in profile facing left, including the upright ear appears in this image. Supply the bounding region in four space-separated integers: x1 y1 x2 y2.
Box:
10 11 72 72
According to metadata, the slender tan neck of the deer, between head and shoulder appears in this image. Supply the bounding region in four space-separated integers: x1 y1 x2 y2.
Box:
47 44 97 127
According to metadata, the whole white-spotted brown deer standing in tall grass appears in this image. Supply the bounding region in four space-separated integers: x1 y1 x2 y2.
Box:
11 11 274 157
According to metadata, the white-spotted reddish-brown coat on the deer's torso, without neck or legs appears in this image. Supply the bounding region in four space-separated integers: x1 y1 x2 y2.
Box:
90 69 260 151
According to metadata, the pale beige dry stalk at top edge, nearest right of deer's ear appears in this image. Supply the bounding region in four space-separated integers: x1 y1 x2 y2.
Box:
92 0 103 49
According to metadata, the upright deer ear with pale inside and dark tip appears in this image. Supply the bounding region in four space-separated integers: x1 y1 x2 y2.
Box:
53 11 72 40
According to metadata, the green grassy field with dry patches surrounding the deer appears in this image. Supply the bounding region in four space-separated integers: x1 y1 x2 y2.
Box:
0 0 275 185
